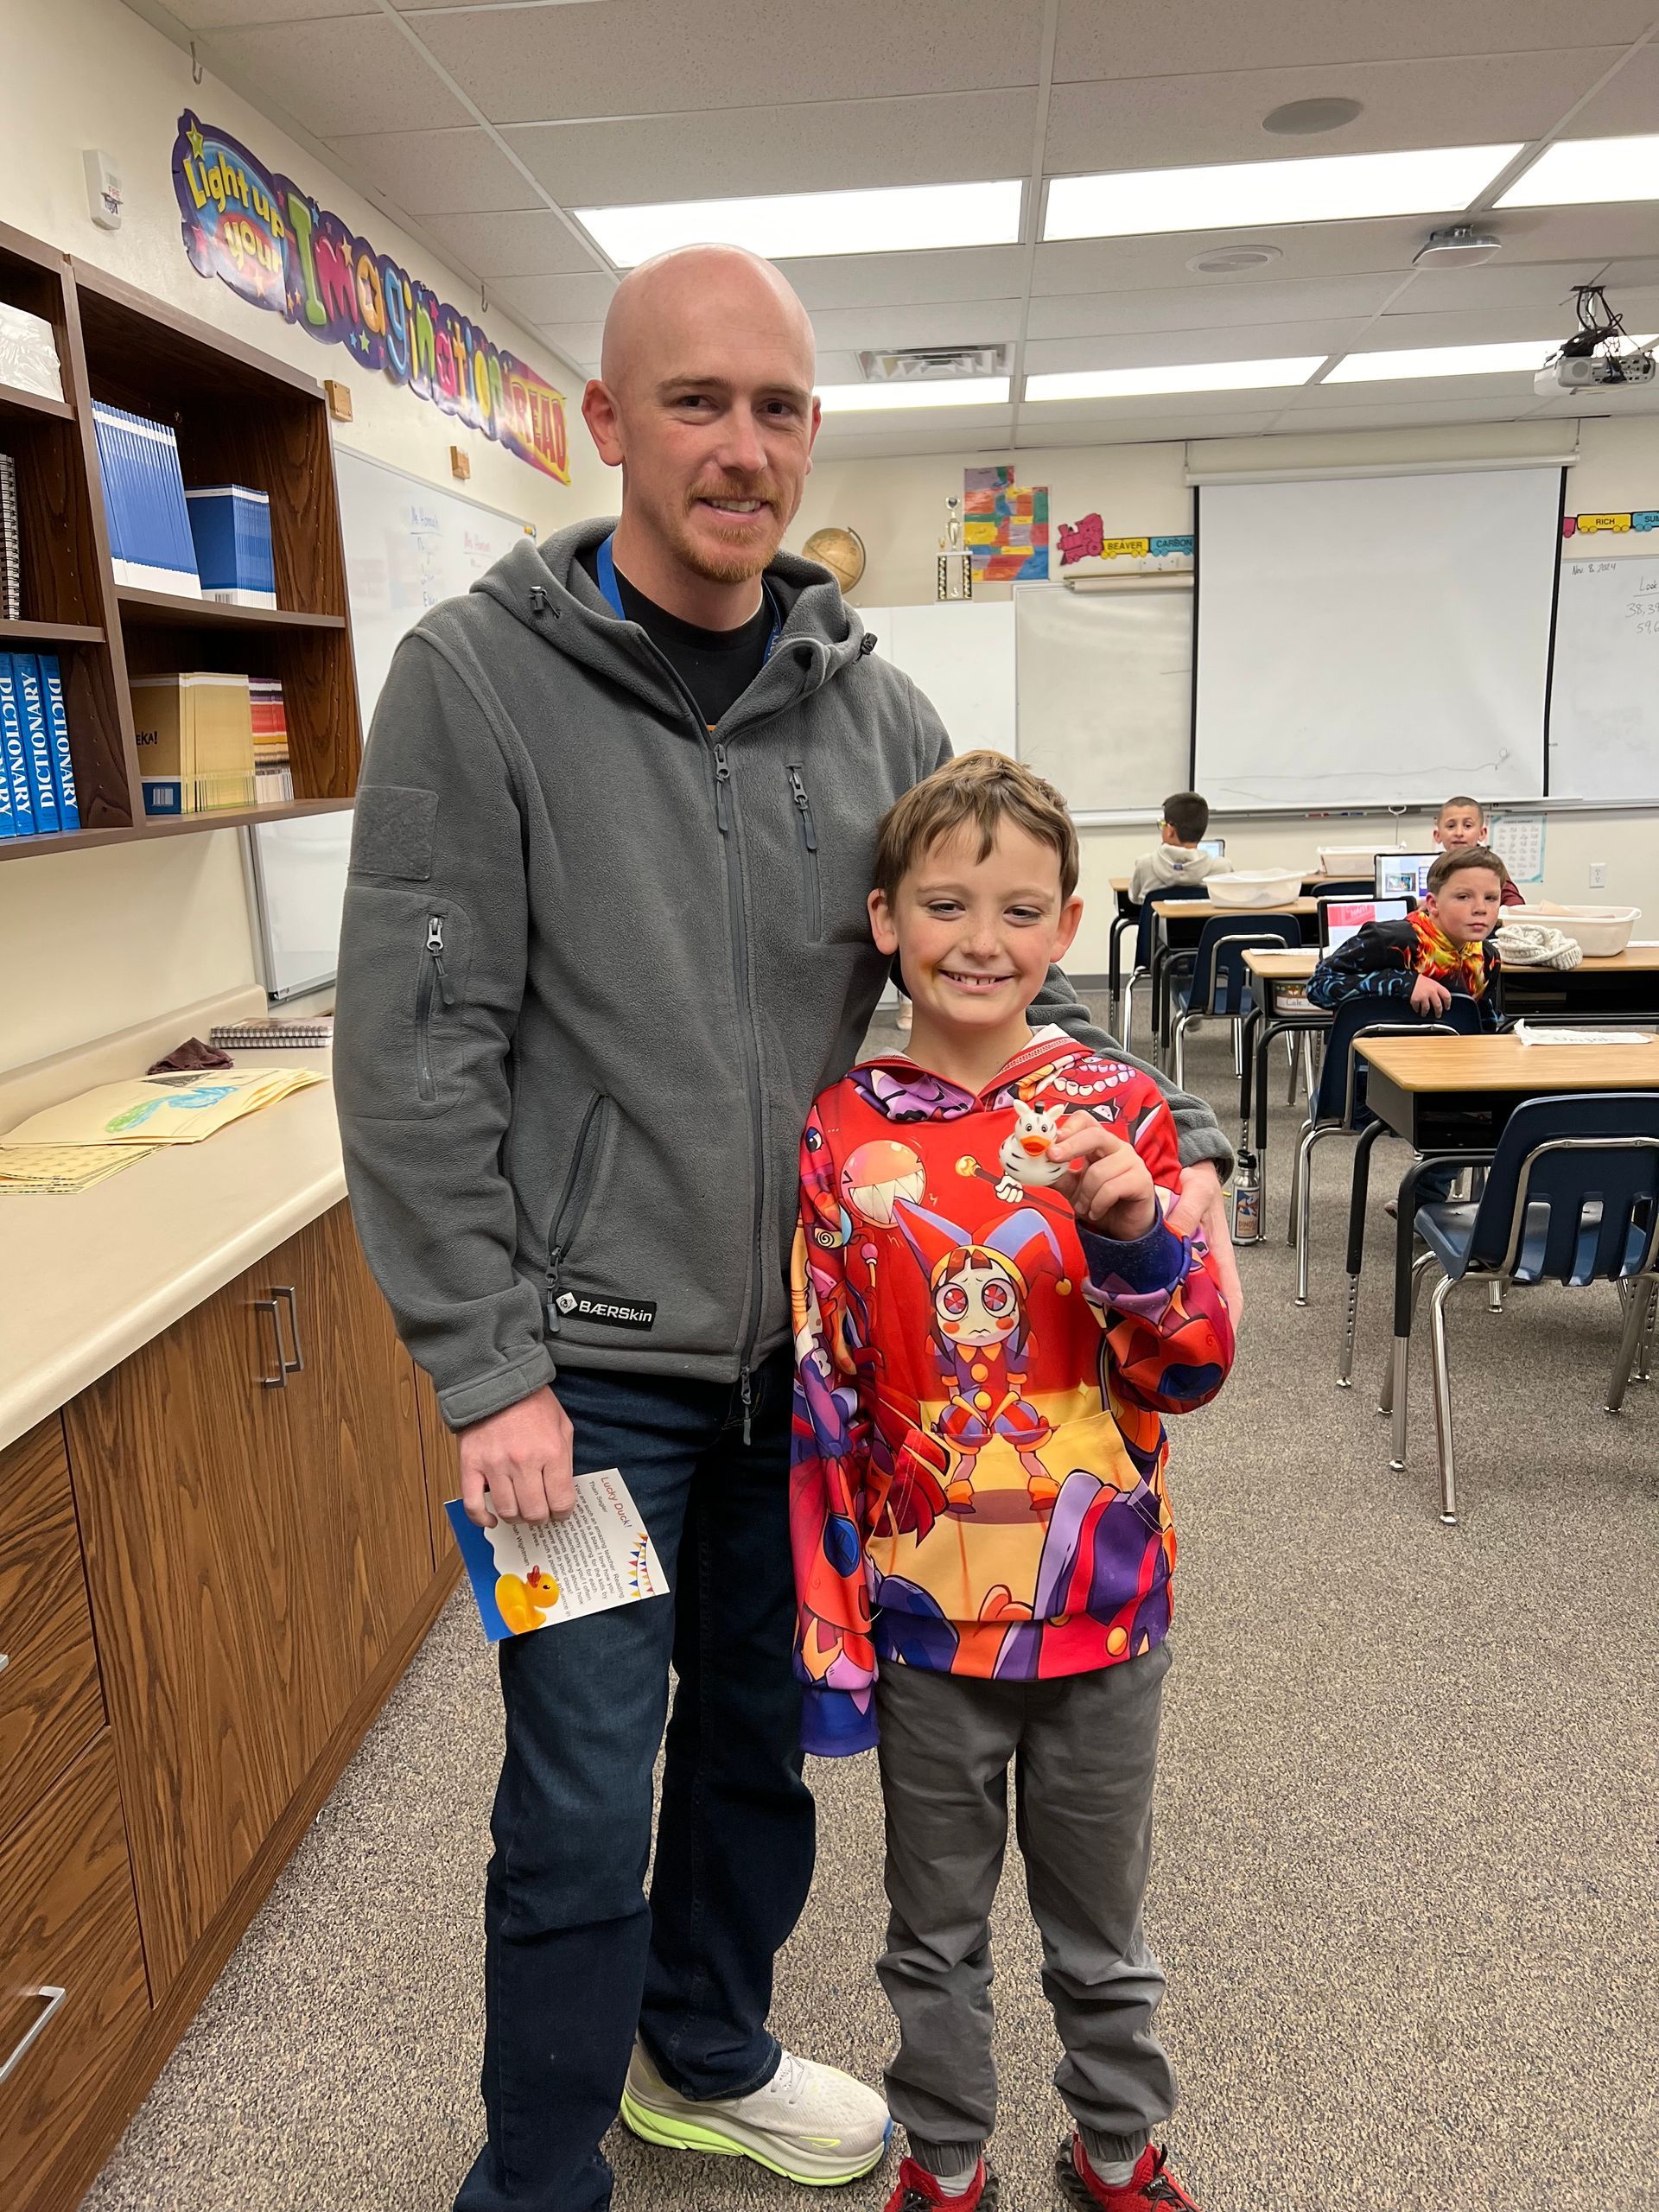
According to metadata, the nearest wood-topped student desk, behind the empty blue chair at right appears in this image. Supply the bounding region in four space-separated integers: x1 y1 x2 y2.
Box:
1350 1030 1659 1465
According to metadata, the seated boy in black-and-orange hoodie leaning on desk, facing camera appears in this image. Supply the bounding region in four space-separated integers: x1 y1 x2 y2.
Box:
1307 844 1506 1028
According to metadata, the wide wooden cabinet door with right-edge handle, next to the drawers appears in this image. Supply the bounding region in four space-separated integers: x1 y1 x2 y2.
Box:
64 1276 339 1998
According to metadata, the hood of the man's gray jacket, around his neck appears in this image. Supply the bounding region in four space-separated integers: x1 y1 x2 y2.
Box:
474 515 876 730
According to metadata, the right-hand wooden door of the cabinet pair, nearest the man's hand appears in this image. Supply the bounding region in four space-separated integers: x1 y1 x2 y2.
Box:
261 1205 431 1719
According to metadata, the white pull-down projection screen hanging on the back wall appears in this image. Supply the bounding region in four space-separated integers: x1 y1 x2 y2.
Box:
1194 467 1564 810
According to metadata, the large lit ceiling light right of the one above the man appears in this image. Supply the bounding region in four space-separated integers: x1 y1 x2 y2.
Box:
1042 146 1520 238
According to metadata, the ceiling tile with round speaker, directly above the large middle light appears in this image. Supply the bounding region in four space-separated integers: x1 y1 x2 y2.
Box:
1044 47 1619 178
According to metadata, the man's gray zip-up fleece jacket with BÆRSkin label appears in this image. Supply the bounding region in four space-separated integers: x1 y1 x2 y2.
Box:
334 522 1232 1429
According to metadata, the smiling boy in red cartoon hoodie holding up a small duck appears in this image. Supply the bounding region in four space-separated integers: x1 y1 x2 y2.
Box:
790 752 1232 2212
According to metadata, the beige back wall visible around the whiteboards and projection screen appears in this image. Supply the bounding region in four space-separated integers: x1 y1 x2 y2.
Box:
790 416 1659 973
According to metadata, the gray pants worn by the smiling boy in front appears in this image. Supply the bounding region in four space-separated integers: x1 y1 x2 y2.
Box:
876 1643 1174 2172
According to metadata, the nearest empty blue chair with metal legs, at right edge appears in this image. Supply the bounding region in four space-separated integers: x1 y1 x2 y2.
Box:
1394 1090 1659 1526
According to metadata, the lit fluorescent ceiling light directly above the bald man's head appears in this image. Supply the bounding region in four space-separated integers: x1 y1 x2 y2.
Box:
575 177 1022 268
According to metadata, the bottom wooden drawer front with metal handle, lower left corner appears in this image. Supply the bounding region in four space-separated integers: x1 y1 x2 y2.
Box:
0 1734 150 2208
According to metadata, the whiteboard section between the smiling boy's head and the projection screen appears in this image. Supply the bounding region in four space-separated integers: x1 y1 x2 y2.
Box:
1013 584 1192 814
